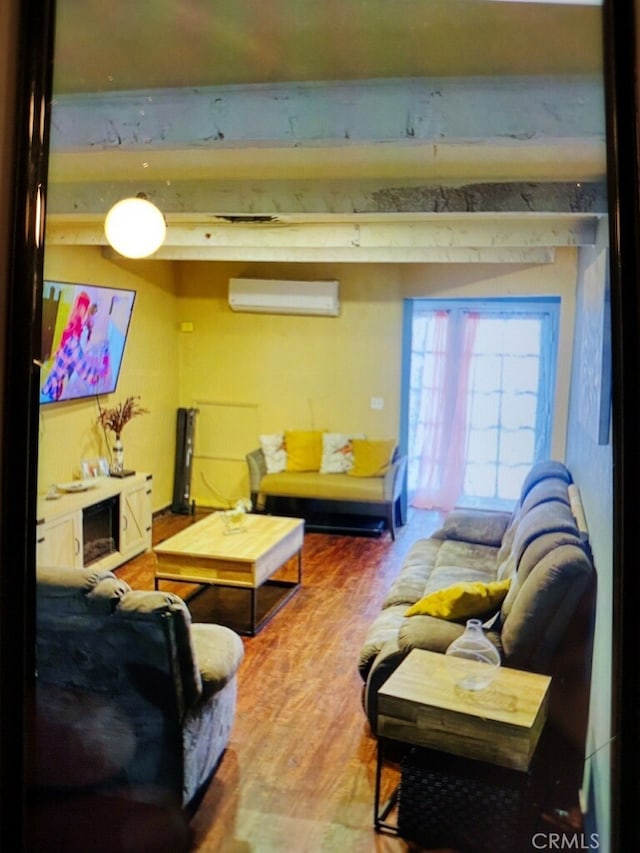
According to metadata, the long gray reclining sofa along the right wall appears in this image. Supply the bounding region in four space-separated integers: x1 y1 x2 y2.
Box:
358 461 595 743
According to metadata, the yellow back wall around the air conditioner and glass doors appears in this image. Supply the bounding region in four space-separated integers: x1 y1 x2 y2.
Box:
178 250 576 506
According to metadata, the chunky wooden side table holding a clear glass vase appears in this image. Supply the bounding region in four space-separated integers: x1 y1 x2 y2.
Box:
374 649 551 853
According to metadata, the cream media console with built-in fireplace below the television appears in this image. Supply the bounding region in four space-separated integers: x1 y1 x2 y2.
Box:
36 474 152 569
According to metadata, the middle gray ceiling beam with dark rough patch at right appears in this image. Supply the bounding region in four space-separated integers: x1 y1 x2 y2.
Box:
47 180 607 219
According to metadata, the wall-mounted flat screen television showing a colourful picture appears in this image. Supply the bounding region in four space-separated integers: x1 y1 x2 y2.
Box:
40 279 136 404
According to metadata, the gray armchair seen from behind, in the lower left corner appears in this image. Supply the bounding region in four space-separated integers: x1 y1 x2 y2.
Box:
35 568 244 811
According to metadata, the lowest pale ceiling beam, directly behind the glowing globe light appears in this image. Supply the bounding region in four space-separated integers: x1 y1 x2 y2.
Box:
46 213 600 264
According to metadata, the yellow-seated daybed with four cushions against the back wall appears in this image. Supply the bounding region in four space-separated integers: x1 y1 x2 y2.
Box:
247 430 406 538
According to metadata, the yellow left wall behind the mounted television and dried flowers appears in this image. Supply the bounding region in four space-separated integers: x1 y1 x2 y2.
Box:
38 246 178 509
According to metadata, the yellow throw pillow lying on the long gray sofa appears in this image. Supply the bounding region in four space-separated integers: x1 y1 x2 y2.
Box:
405 578 511 621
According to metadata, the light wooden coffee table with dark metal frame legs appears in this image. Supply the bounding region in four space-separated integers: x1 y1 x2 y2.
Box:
153 512 304 636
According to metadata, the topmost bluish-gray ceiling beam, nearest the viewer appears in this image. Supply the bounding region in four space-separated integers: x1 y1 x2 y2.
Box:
51 76 604 153
